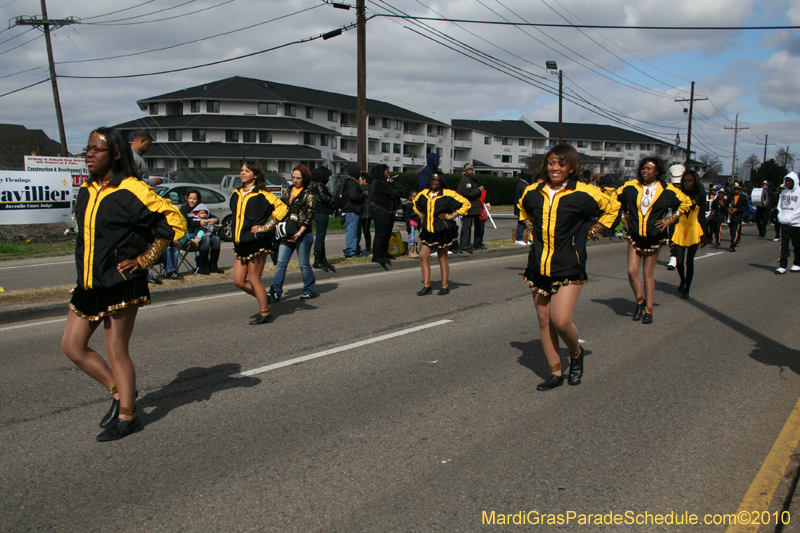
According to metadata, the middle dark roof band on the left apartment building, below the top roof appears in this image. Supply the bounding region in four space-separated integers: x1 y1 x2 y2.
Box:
114 113 339 135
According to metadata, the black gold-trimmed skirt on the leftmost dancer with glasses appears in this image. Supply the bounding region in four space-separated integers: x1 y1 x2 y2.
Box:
69 276 150 322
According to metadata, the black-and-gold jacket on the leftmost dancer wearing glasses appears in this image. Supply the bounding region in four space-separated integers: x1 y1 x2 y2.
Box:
75 174 186 290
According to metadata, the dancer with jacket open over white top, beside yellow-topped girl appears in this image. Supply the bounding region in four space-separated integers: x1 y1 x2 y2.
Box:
617 157 692 324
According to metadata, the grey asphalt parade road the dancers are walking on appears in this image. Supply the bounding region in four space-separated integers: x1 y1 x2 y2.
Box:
0 227 800 532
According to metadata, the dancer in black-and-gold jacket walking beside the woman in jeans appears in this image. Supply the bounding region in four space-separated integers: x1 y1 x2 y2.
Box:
231 161 289 326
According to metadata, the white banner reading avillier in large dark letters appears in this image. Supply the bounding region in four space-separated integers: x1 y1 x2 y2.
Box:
0 170 72 225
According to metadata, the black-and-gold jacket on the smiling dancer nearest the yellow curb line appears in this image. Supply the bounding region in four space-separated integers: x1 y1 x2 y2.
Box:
518 176 619 277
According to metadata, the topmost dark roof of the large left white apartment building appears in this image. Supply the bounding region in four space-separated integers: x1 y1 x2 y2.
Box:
137 76 444 125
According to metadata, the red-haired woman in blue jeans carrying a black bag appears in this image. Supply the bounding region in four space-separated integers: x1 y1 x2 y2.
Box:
269 165 317 302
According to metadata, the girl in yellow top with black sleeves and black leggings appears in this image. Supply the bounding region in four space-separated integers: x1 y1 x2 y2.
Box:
672 170 708 300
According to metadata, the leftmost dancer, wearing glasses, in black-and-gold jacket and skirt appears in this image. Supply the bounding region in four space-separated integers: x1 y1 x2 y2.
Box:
61 128 186 442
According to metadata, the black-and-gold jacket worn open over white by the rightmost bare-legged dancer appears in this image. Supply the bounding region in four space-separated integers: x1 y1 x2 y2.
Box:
617 179 692 237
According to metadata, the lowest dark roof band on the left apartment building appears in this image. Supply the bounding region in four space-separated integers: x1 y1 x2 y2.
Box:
145 142 323 161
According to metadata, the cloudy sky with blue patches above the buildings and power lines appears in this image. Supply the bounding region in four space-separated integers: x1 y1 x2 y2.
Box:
0 0 800 172
